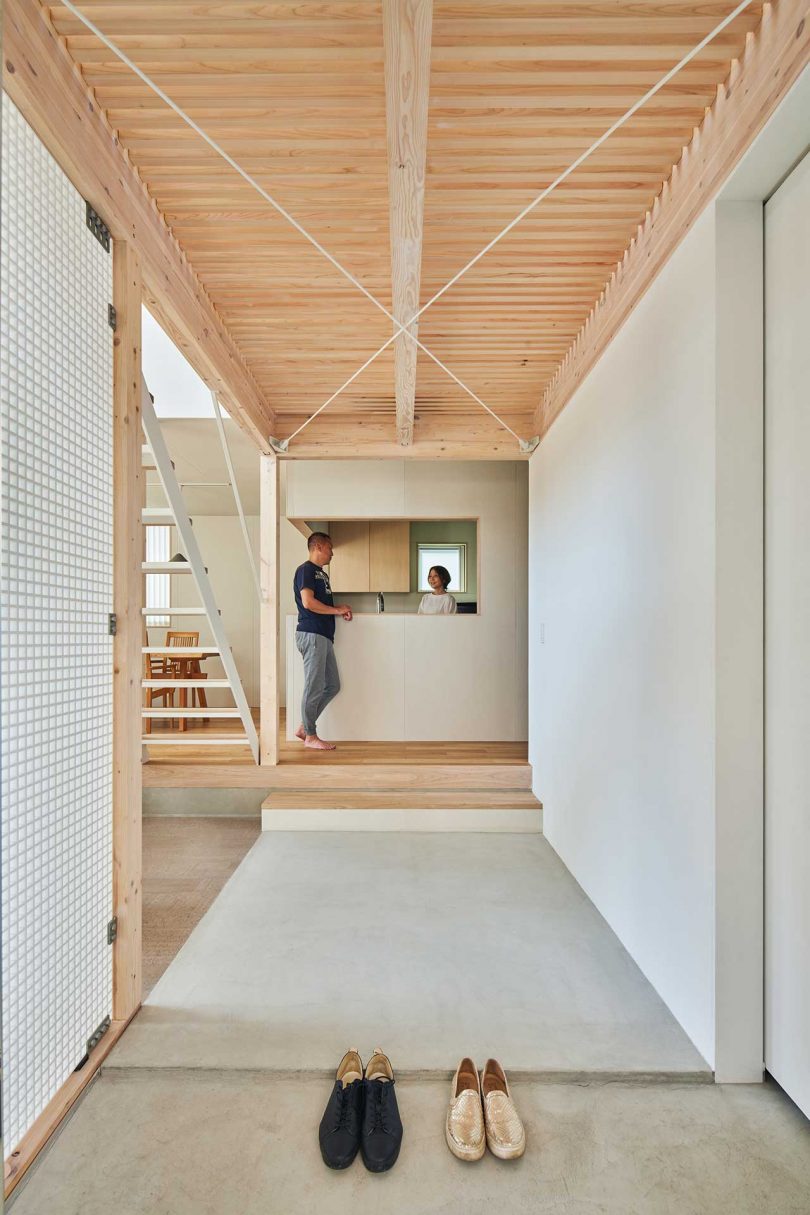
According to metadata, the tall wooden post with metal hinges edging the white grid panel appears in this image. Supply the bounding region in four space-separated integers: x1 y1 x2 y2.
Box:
113 241 143 1021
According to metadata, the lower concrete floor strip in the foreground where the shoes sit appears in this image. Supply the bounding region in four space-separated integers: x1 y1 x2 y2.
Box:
13 1061 810 1215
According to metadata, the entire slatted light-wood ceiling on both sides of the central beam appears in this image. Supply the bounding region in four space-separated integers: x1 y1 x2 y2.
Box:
51 0 761 453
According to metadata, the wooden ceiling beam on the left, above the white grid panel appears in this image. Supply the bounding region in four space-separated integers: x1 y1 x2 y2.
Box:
2 0 274 452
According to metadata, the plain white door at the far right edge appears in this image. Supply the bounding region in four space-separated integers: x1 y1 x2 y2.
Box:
765 156 810 1115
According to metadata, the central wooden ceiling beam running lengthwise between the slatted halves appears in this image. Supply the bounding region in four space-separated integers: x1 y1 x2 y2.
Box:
383 0 434 446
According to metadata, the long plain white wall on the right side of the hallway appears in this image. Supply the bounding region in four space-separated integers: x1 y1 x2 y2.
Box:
529 68 810 1081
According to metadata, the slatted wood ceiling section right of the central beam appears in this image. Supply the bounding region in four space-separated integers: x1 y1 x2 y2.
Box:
417 0 760 435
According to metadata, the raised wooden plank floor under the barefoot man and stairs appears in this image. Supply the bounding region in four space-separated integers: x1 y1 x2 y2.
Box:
143 710 527 787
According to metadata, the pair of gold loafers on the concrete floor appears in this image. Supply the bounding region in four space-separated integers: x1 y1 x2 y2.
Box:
444 1058 526 1160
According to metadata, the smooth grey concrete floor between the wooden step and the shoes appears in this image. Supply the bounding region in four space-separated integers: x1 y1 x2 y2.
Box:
111 832 708 1078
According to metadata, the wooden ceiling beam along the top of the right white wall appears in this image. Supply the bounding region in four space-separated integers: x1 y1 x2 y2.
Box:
536 0 810 436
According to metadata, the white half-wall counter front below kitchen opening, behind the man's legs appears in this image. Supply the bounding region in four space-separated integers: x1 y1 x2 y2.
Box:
287 612 526 742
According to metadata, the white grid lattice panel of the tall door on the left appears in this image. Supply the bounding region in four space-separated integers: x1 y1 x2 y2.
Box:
0 96 113 1153
